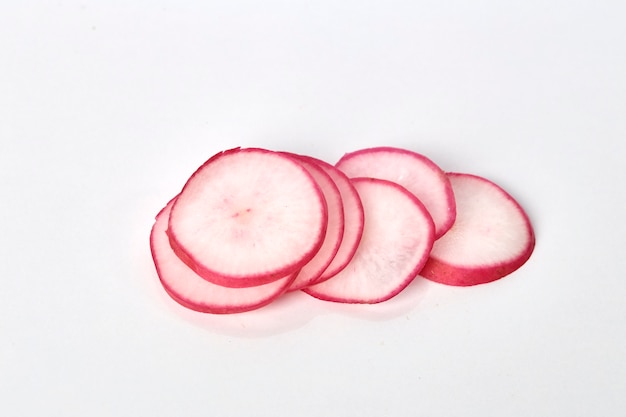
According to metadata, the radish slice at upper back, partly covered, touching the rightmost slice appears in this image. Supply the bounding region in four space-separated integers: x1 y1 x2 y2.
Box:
335 147 456 238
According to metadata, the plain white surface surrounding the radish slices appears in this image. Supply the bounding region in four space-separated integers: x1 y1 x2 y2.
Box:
0 0 626 417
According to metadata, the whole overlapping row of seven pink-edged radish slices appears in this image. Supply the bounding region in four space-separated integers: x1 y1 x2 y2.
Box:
150 147 535 313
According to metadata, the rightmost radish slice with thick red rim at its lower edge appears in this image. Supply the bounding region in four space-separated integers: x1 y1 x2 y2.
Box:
420 173 535 286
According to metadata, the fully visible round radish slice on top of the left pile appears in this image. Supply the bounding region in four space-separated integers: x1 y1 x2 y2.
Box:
168 148 328 287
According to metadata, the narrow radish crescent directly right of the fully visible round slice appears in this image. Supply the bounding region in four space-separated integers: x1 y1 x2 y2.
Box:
286 153 343 291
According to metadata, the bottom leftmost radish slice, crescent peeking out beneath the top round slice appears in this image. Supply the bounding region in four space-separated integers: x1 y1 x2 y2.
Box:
150 201 295 314
